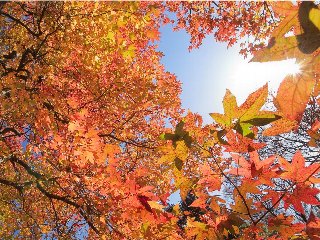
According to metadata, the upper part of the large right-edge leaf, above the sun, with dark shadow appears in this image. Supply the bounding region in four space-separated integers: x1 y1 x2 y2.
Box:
251 2 320 62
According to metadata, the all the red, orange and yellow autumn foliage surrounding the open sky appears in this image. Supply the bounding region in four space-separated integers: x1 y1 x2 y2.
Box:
0 2 320 239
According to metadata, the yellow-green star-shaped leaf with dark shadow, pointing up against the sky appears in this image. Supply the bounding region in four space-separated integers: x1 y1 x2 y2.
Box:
210 84 280 137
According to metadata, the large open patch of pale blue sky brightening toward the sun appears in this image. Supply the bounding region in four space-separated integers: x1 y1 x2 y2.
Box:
159 25 295 123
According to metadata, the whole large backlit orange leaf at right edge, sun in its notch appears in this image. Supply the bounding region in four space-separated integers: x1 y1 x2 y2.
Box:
251 2 320 128
